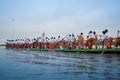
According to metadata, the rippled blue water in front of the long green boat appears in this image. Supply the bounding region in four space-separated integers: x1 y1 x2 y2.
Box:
0 47 120 80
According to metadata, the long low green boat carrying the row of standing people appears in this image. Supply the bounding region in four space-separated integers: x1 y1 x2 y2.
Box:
30 48 120 53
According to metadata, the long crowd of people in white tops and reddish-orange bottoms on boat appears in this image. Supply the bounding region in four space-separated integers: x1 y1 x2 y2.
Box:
6 29 120 50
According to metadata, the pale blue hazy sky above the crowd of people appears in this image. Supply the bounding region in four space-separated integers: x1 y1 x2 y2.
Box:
0 0 120 44
